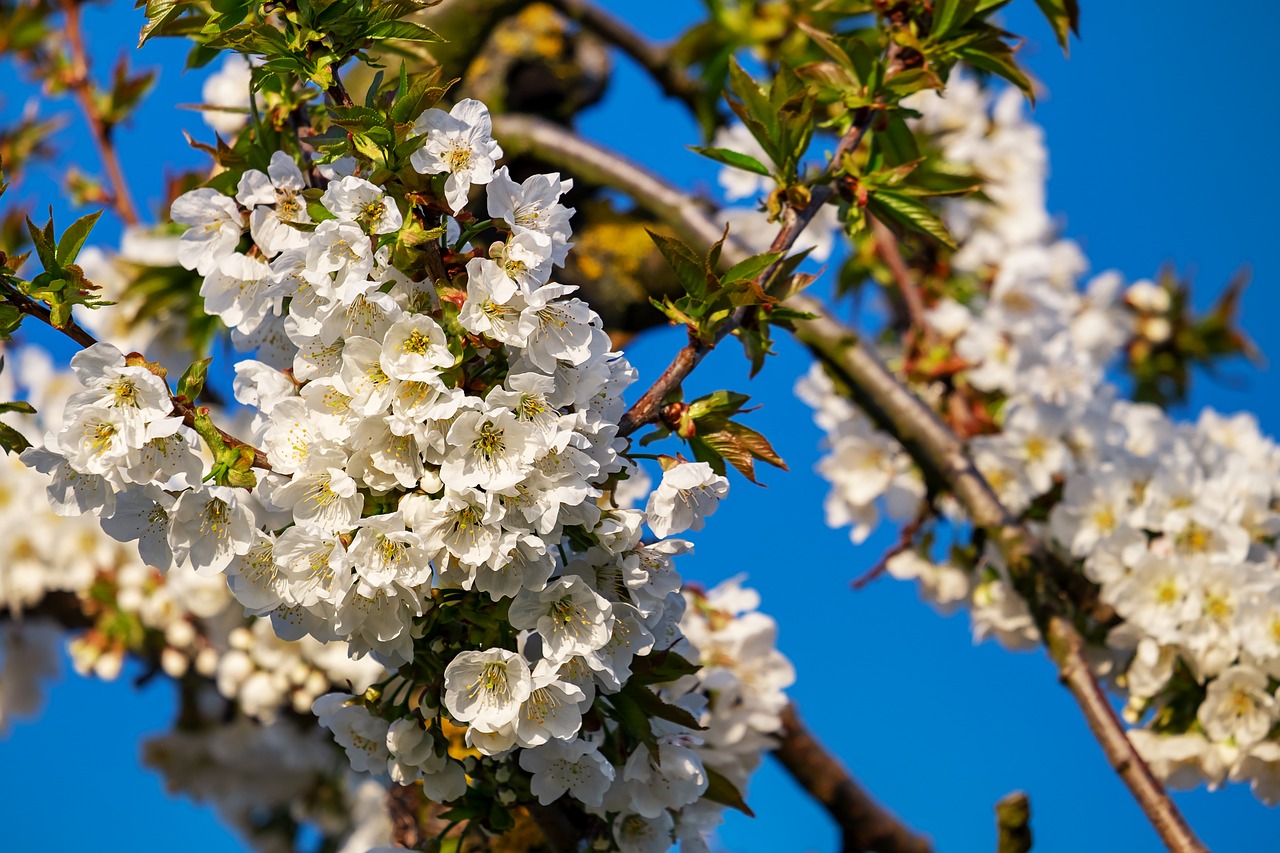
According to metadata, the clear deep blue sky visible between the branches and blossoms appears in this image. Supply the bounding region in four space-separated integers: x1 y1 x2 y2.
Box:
0 0 1280 853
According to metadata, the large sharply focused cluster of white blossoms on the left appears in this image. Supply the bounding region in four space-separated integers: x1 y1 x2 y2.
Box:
10 100 791 850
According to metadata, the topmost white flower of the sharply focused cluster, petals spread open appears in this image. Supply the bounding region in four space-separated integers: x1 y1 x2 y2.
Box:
410 97 502 211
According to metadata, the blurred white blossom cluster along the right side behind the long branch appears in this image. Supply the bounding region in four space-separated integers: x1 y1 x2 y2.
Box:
799 78 1280 803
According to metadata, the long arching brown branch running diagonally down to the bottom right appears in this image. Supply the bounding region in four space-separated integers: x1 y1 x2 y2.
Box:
494 109 1206 853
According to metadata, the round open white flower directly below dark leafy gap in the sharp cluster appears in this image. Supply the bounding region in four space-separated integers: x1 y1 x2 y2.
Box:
444 648 534 731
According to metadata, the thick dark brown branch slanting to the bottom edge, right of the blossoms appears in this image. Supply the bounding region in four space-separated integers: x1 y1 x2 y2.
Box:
773 704 932 853
